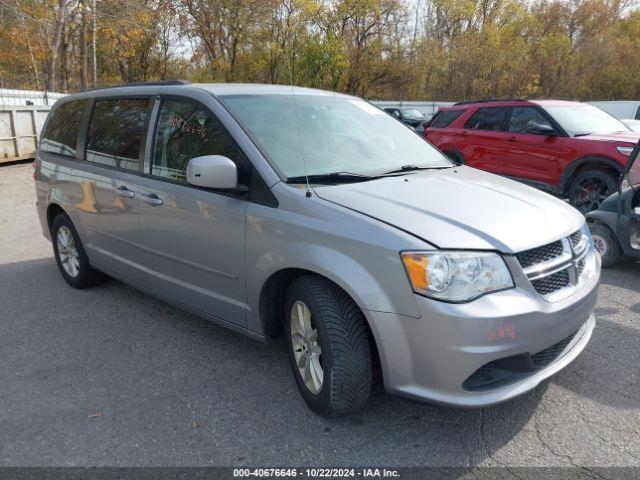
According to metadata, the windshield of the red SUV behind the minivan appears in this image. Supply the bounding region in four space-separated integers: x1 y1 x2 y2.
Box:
544 103 631 137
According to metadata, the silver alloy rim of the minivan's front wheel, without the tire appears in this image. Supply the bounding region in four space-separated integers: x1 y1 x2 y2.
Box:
290 300 324 395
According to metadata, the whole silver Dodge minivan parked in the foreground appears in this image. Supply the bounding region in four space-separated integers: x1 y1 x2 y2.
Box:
35 82 600 415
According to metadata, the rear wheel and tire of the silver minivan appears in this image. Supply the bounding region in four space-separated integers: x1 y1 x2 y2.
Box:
51 213 104 289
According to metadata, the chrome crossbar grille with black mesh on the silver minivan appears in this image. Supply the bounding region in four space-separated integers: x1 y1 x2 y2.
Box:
515 230 589 299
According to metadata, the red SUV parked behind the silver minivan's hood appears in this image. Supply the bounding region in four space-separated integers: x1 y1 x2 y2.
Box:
425 100 640 213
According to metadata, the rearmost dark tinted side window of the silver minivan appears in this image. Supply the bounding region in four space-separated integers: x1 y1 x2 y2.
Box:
40 100 85 157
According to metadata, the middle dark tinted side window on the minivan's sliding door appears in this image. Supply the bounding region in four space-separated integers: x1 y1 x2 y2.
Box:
87 98 149 170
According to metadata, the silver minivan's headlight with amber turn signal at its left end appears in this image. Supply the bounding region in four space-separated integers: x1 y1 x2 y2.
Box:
401 251 515 302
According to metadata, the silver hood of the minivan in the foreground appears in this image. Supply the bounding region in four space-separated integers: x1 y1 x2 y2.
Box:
315 166 584 253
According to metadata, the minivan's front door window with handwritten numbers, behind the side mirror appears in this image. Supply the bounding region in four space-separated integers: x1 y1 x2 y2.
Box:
152 100 238 182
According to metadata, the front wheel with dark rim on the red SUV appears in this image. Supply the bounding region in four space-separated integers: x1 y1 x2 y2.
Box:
568 169 618 214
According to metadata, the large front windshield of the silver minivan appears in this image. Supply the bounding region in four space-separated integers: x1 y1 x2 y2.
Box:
217 94 453 178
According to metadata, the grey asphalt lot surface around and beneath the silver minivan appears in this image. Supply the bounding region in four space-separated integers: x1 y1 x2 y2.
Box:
0 164 640 467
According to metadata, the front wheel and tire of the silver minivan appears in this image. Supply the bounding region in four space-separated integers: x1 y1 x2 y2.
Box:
284 275 373 417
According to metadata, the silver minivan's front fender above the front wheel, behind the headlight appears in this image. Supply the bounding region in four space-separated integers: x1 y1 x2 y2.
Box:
246 193 428 334
